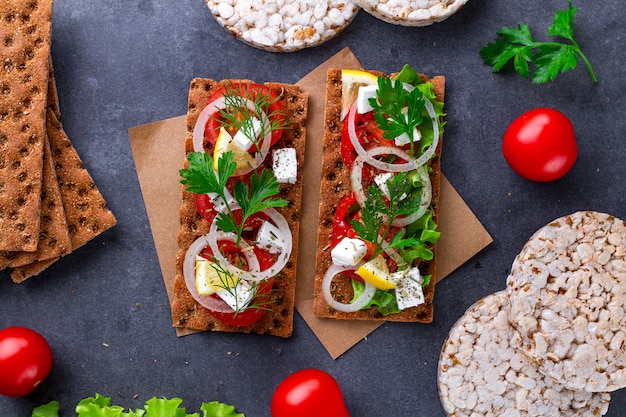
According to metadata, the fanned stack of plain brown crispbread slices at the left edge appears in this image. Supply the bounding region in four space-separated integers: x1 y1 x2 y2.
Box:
0 0 116 282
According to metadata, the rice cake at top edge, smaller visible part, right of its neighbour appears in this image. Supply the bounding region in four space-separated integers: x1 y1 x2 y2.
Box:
354 0 468 26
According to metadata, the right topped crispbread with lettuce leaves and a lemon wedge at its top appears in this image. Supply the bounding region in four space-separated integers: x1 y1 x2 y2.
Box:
313 65 445 323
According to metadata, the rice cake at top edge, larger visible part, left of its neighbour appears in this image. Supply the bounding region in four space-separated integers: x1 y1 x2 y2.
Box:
205 0 360 52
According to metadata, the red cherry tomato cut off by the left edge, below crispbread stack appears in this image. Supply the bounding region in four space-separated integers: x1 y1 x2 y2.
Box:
0 326 52 397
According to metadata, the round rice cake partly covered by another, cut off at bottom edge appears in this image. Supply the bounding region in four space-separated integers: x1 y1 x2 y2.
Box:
438 290 611 417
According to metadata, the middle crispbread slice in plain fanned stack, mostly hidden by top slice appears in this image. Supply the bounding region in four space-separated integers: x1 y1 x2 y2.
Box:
0 135 72 269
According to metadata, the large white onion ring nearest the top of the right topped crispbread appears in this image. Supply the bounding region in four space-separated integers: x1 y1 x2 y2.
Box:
345 89 439 172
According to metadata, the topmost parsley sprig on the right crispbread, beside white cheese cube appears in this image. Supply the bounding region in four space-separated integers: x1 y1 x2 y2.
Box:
369 77 425 155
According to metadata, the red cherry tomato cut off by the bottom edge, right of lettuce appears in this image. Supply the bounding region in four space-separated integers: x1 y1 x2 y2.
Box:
271 368 350 417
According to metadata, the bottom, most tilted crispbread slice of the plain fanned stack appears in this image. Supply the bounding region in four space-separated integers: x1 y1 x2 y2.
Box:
11 109 117 283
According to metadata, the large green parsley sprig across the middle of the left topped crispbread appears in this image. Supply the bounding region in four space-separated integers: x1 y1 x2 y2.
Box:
179 151 289 244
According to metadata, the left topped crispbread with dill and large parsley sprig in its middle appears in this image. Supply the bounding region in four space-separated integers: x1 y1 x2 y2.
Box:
172 78 308 337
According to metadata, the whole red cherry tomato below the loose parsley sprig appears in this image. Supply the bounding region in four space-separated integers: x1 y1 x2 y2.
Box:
502 108 578 182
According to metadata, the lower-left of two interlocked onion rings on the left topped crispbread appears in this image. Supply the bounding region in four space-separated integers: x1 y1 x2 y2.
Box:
183 233 260 313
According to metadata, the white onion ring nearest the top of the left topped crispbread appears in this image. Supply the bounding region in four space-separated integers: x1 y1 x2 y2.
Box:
193 96 272 176
